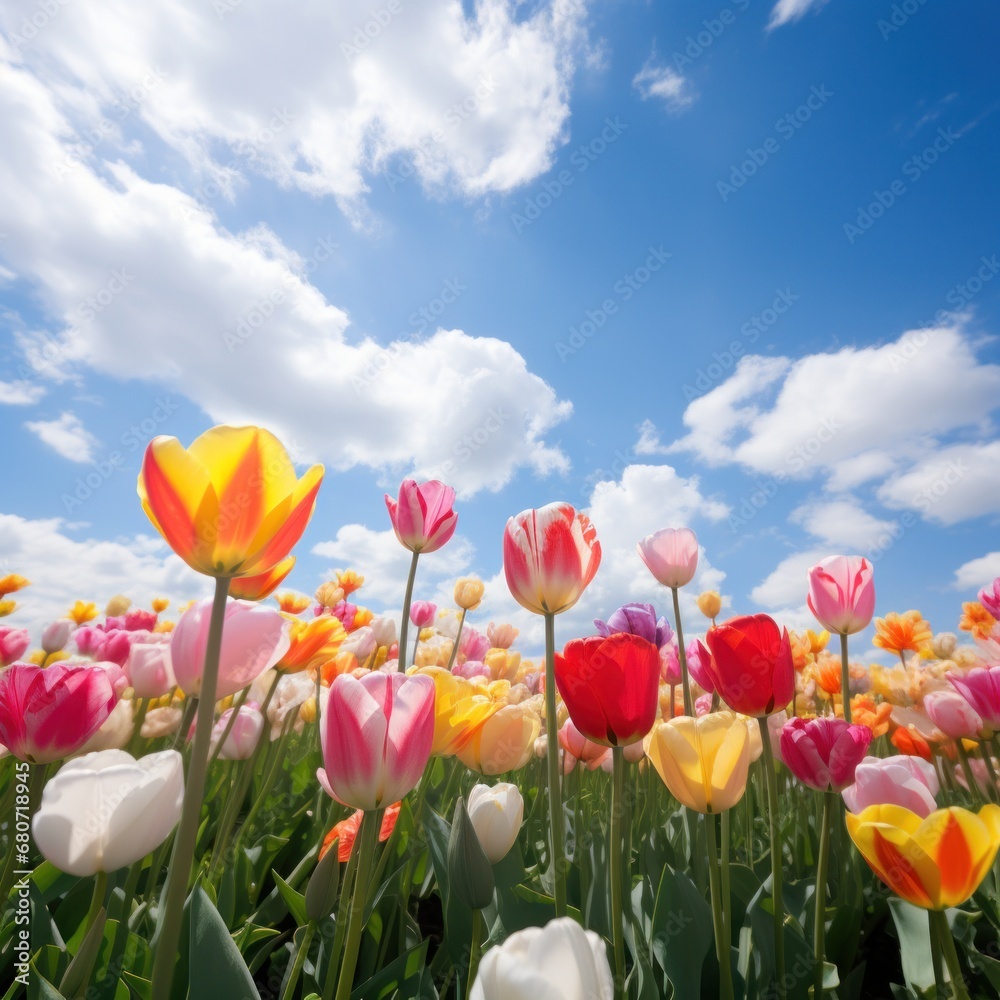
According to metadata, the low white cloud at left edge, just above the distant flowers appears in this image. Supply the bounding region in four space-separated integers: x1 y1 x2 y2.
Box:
0 514 205 643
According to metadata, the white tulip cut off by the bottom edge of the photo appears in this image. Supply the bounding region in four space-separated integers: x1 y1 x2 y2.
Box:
469 917 615 1000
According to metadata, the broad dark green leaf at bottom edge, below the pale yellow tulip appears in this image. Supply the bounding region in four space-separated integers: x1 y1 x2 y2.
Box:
652 865 715 997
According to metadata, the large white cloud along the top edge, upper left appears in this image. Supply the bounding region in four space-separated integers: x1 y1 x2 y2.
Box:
0 0 590 202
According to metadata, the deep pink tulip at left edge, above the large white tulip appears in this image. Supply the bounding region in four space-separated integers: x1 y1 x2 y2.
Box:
0 663 117 764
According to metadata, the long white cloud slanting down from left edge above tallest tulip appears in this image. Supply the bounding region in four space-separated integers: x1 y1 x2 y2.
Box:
0 58 571 495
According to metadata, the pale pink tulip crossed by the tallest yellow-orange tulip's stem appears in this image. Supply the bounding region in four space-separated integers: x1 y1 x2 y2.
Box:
170 599 289 699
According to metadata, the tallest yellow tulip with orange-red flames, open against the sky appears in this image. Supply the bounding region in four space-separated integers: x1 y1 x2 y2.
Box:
138 426 323 578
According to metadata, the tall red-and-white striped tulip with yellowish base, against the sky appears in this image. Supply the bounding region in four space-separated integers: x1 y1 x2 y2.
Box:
503 503 601 615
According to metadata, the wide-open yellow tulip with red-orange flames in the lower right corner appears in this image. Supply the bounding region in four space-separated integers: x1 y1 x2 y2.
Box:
846 805 1000 910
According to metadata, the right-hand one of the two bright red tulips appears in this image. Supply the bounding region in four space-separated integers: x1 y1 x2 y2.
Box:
706 615 795 716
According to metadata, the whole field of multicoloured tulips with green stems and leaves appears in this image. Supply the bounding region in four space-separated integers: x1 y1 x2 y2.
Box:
0 426 1000 1000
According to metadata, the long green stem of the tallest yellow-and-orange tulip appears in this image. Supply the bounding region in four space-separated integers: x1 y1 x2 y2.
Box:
151 576 229 1000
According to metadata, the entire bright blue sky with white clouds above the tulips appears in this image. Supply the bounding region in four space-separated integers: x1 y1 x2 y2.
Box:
0 0 1000 648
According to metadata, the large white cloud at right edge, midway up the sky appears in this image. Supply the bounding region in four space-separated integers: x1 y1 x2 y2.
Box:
670 330 1000 523
